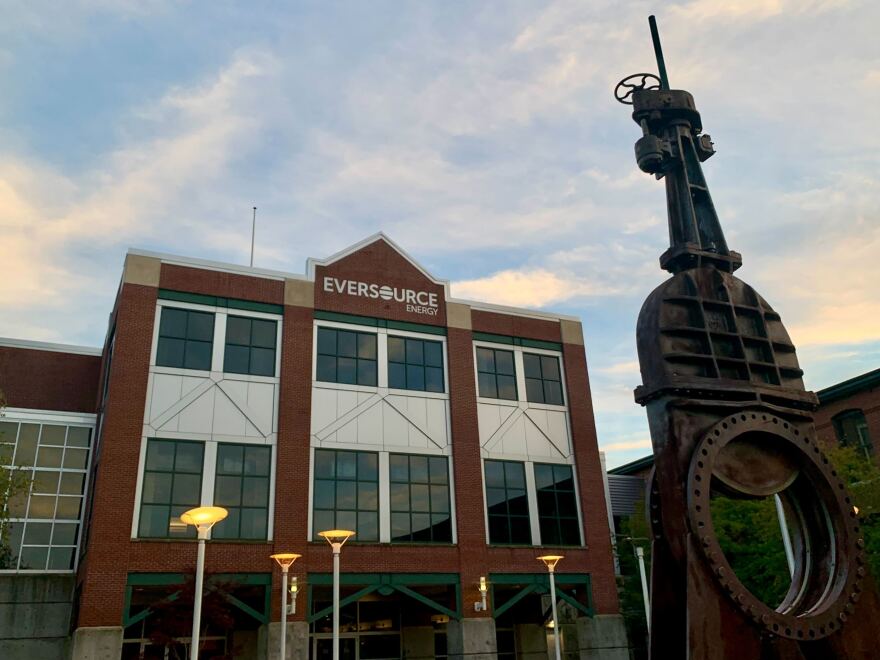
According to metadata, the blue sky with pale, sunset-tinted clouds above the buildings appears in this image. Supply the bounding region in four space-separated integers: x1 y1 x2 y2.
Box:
0 0 880 467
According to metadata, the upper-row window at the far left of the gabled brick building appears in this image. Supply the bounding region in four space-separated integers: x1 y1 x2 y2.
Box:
156 307 214 371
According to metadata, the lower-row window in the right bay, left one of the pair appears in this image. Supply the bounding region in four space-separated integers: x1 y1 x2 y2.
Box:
485 461 532 544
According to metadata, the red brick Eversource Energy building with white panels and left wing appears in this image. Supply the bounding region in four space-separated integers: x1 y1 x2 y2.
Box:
0 234 627 660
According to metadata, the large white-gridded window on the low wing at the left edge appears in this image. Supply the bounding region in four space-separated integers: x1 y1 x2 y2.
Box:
0 420 92 571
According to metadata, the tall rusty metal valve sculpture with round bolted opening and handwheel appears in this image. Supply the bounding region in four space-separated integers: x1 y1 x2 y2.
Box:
615 16 880 660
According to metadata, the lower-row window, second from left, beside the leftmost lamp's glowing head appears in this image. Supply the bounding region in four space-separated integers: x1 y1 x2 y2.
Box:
211 443 272 539
